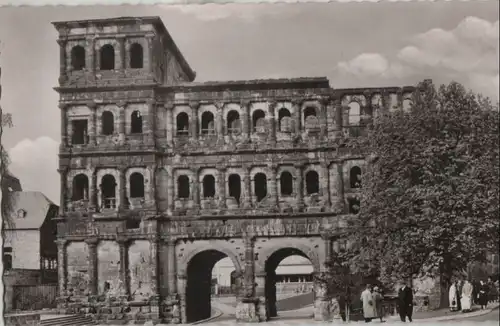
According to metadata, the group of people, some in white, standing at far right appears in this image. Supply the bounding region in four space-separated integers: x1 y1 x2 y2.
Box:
449 280 498 312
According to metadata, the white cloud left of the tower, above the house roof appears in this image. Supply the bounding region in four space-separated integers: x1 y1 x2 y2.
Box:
9 136 60 205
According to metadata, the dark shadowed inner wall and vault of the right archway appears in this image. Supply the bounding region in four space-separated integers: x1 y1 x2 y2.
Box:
264 248 313 319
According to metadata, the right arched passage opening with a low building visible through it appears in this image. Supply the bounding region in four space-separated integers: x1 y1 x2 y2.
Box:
265 248 314 318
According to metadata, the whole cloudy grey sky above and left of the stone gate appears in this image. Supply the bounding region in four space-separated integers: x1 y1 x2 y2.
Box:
0 1 499 203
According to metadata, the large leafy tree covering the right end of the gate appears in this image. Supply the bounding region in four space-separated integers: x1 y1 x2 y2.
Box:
346 81 499 304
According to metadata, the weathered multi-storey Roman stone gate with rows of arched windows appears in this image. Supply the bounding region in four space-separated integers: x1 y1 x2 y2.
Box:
54 17 414 324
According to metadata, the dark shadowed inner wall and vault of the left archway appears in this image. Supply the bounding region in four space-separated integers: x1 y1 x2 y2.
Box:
185 249 238 323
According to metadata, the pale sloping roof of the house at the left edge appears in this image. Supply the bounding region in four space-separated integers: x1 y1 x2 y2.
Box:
5 191 54 230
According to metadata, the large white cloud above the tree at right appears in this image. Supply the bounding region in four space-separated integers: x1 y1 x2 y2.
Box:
337 17 499 99
